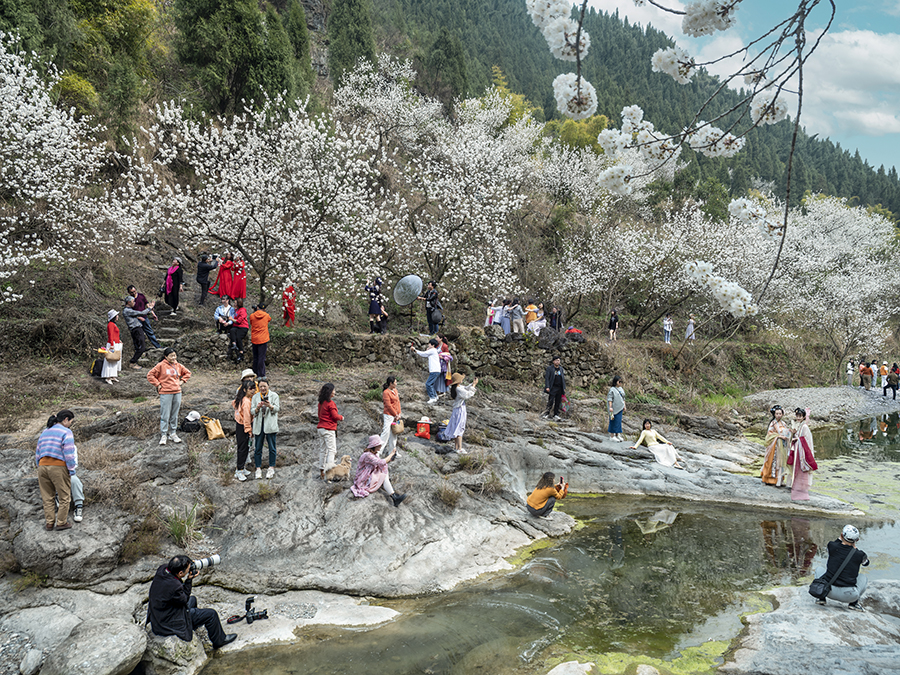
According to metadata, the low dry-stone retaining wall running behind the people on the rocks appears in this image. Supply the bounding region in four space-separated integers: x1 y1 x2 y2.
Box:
178 328 613 387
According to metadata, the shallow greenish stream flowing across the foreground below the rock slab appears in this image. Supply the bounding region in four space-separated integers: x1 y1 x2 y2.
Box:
203 496 900 675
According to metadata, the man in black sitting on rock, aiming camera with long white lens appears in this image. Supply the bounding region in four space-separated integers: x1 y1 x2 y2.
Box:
147 555 237 649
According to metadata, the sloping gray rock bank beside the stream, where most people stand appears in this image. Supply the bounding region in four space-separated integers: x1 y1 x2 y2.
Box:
0 368 888 675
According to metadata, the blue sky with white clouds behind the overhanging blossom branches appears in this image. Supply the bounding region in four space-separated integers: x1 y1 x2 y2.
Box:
590 0 900 168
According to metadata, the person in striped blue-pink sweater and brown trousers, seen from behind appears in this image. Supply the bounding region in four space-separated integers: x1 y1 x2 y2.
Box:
34 410 78 530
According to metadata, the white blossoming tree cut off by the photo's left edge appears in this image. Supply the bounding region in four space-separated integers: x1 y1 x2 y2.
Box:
0 32 110 304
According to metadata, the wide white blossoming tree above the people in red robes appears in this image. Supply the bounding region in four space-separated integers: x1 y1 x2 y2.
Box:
109 101 390 310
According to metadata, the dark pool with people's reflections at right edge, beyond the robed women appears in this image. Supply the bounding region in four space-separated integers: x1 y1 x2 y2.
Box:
813 413 900 462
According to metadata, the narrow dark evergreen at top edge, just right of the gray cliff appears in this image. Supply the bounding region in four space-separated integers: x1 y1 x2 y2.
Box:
328 0 375 88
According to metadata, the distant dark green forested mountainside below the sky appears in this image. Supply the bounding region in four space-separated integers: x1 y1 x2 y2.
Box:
374 0 900 214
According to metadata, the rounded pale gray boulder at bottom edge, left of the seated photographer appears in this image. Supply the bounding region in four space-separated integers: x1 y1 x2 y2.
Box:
41 618 147 675
